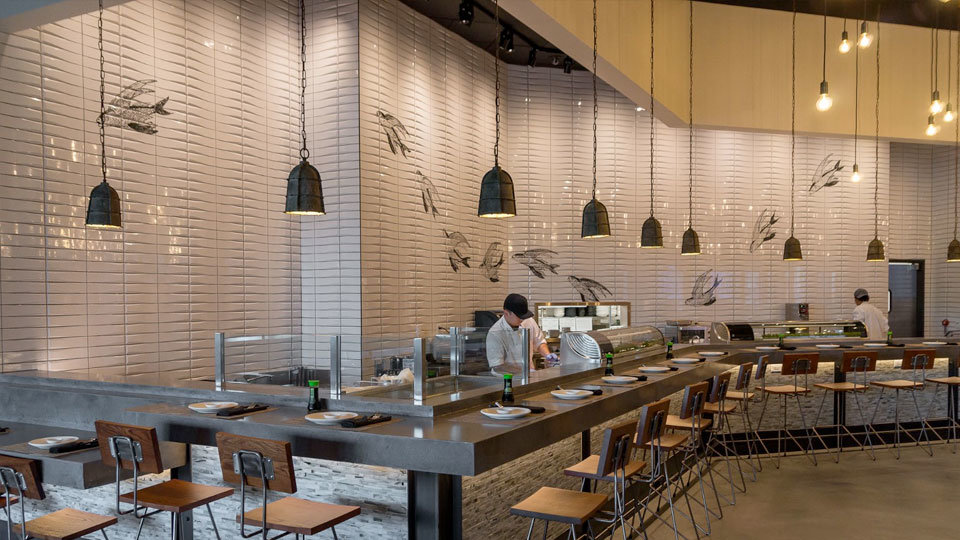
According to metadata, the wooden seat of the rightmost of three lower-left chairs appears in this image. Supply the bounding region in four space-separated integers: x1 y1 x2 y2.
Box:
237 497 360 536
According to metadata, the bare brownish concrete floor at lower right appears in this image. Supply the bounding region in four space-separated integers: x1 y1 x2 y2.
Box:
640 444 960 540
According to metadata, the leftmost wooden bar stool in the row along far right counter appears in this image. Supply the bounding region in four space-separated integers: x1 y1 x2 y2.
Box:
757 352 826 469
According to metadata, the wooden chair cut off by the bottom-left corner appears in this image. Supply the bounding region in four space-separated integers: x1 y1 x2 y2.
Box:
0 466 117 540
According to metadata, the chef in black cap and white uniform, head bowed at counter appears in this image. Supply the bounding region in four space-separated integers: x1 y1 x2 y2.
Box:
487 293 558 375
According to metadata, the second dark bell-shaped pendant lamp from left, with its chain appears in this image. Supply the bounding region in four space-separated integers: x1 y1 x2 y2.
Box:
283 0 327 216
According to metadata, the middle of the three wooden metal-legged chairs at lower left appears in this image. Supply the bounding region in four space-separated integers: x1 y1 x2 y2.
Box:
96 420 233 540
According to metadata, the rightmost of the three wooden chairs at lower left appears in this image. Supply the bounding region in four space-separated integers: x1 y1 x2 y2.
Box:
217 432 360 540
